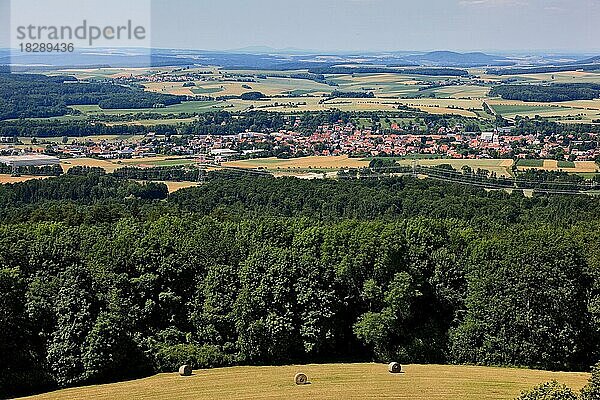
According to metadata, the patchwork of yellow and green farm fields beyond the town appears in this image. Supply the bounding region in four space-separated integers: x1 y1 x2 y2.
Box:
32 67 600 125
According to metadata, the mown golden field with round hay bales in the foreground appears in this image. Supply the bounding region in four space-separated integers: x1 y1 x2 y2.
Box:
17 364 589 400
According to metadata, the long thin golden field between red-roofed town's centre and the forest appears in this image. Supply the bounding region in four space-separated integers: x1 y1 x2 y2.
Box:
223 156 369 170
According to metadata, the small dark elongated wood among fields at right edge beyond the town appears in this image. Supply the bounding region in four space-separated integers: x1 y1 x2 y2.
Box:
490 83 600 102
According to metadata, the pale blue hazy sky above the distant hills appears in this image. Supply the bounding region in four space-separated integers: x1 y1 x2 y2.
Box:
0 0 600 53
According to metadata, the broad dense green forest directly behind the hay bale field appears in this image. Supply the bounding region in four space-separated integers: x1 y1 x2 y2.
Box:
0 168 600 396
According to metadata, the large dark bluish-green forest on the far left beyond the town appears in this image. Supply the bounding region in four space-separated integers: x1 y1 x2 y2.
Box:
0 73 184 120
